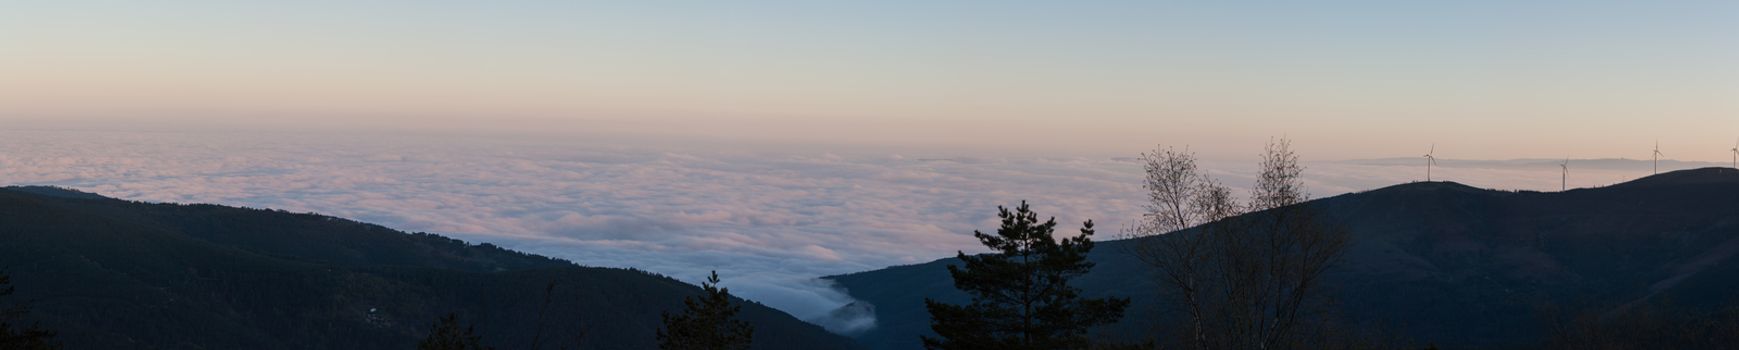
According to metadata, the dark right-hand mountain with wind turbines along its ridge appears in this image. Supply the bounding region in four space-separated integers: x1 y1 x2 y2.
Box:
826 169 1739 348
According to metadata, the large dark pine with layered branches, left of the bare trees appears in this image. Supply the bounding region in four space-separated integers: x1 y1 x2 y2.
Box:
922 202 1129 350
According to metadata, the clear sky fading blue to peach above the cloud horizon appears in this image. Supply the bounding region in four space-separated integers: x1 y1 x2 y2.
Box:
0 0 1739 160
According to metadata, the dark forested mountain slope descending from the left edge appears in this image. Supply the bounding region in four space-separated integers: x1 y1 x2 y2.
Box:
0 188 856 348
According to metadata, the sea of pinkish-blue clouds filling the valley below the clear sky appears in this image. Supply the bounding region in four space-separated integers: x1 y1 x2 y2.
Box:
0 131 1711 333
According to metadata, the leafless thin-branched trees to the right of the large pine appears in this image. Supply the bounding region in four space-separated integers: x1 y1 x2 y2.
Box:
1136 139 1349 348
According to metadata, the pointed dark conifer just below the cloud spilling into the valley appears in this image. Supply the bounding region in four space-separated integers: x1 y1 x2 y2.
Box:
657 272 755 350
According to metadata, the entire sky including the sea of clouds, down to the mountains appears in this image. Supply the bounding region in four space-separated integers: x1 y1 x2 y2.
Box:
0 0 1739 334
